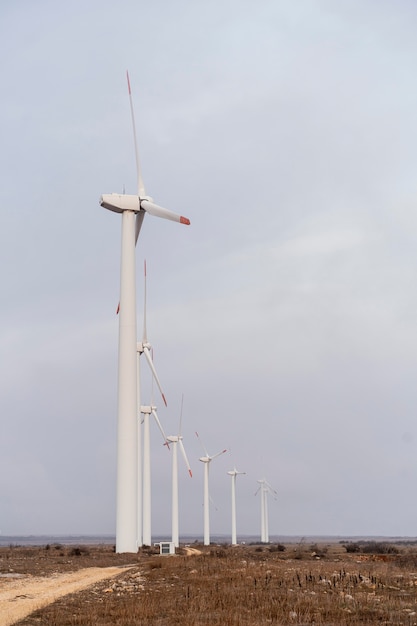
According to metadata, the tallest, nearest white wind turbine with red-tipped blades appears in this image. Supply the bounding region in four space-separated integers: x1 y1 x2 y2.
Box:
100 74 190 553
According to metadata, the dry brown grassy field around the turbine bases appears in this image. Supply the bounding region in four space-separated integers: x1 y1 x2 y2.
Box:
0 543 417 626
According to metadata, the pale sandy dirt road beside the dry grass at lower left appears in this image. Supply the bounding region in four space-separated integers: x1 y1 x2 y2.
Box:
0 567 130 626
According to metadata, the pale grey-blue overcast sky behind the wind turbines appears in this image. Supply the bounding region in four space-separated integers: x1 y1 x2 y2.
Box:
0 0 417 537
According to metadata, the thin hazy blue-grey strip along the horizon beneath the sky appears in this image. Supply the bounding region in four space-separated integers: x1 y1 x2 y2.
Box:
0 535 417 547
